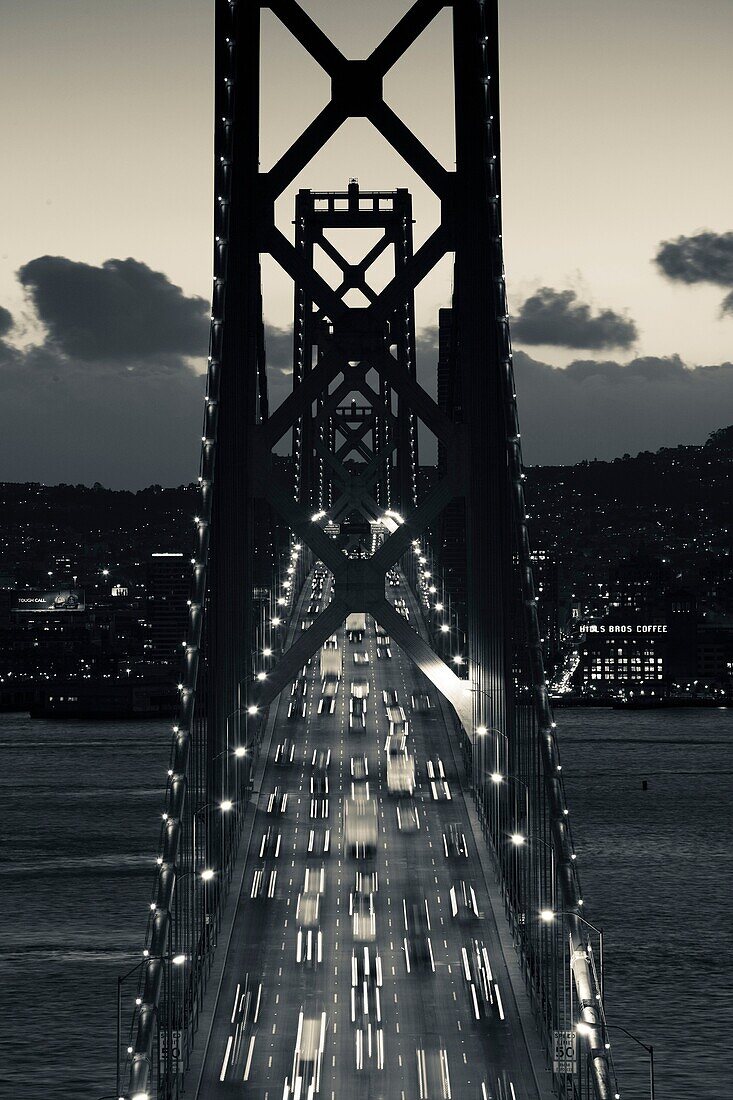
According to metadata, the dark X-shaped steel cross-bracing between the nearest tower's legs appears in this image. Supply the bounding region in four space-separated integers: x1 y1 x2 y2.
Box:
249 0 473 728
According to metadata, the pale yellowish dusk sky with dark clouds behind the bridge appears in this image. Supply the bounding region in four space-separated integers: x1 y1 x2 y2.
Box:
0 0 733 486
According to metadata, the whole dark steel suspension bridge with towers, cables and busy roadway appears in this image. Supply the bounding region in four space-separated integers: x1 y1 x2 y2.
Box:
117 0 620 1100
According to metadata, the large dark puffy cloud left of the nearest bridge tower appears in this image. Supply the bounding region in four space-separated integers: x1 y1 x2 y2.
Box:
18 256 208 362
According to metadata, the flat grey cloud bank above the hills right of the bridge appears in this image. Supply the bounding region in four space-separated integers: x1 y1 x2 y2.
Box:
514 351 733 464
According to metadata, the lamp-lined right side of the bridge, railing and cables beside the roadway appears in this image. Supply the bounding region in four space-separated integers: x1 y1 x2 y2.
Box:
412 542 619 1100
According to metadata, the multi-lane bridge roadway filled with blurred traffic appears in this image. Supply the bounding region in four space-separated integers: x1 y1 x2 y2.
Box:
193 579 539 1100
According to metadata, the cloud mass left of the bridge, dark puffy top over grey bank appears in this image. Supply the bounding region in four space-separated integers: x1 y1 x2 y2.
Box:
0 256 208 487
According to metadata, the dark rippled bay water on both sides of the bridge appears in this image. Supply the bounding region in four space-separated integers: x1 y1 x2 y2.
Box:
0 710 733 1100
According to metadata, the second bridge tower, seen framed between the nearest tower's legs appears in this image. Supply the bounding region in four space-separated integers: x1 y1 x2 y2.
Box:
293 180 417 524
